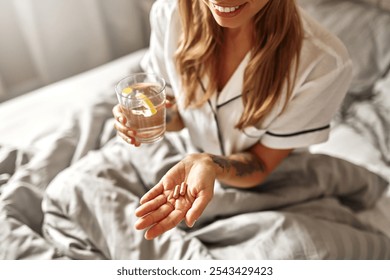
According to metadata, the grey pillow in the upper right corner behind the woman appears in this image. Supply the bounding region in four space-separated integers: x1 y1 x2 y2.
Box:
298 0 390 94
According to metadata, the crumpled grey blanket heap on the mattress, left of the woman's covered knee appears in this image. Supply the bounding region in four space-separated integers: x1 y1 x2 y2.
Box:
0 94 115 259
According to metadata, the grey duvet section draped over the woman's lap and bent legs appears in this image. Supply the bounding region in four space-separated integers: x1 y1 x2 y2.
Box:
43 130 390 259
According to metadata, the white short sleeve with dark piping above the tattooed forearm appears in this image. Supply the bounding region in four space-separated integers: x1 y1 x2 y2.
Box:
260 58 352 149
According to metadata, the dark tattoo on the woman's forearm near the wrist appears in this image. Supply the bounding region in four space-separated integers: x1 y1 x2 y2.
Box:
211 154 265 177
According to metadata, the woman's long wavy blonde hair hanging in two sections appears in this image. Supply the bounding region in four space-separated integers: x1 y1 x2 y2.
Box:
175 0 303 129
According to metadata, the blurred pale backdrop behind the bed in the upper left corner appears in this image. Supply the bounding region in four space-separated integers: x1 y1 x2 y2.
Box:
0 0 153 102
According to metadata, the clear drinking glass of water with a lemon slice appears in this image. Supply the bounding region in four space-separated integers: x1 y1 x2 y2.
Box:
115 73 166 143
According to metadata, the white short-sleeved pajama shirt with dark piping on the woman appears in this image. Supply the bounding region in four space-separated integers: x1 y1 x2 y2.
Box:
141 0 352 155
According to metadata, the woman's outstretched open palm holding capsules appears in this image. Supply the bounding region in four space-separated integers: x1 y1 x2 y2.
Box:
135 156 215 239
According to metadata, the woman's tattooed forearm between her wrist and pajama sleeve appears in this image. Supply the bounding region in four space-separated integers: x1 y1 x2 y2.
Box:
209 152 269 188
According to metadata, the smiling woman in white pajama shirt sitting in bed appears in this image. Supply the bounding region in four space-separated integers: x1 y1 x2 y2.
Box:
113 0 351 239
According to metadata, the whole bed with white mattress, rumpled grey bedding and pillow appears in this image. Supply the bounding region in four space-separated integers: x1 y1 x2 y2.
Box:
0 0 390 259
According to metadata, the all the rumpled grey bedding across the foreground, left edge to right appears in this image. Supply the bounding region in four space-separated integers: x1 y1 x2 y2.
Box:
0 96 390 259
